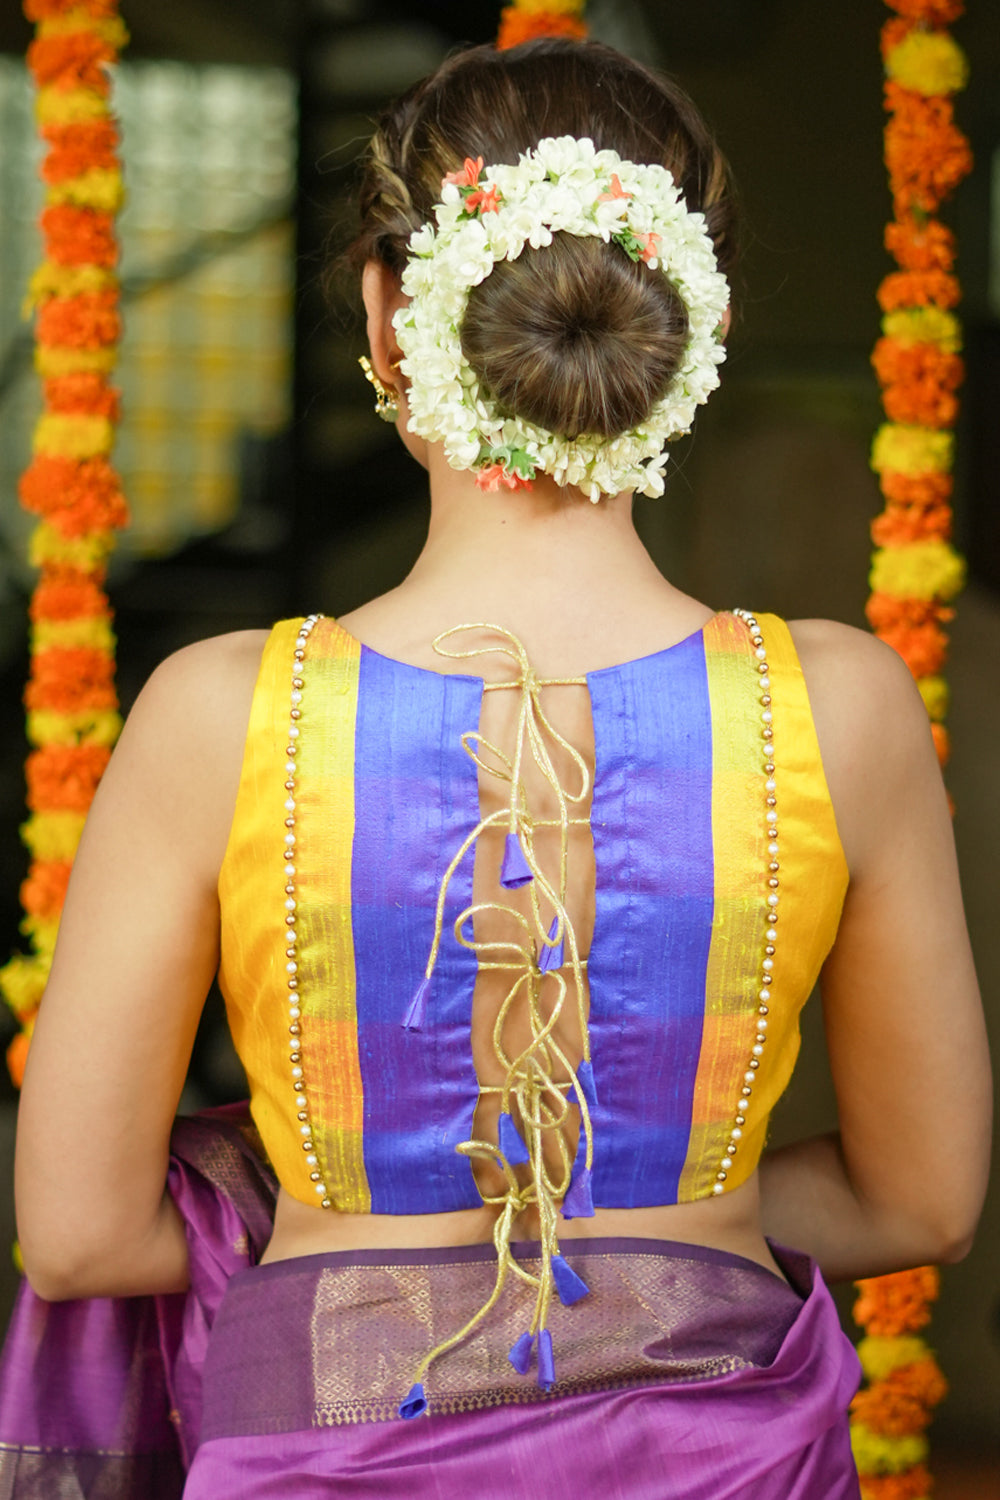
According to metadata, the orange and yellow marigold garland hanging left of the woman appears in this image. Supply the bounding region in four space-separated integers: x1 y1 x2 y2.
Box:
0 0 127 1086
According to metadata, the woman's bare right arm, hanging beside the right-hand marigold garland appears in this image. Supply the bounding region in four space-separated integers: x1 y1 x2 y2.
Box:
762 621 991 1278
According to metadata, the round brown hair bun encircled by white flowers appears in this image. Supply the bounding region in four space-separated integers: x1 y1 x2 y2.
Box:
462 234 688 438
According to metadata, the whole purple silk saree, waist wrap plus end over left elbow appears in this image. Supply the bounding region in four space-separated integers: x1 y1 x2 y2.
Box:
0 1110 859 1500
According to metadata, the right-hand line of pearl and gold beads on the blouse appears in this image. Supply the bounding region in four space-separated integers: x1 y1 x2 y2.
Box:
712 609 781 1196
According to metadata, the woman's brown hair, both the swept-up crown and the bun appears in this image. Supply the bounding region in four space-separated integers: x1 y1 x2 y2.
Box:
351 39 736 438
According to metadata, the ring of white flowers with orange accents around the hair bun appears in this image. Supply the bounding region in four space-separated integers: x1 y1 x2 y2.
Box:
393 135 729 501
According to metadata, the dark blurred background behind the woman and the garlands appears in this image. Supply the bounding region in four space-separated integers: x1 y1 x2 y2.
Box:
0 0 1000 1476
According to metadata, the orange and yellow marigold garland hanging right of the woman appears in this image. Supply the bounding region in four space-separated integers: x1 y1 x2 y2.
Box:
852 0 972 1500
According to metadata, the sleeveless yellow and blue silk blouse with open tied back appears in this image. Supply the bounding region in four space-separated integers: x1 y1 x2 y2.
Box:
219 614 847 1214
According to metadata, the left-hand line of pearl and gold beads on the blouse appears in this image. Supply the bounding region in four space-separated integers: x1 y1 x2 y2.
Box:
282 615 333 1209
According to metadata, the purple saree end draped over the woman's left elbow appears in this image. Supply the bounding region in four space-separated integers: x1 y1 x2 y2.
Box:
0 1106 277 1500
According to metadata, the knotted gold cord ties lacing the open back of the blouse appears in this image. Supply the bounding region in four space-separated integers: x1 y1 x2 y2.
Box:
400 624 594 1416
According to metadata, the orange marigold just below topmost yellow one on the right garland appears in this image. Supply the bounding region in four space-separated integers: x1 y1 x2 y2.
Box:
885 83 972 219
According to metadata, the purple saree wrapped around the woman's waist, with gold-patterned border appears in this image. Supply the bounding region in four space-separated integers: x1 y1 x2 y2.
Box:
184 1239 859 1500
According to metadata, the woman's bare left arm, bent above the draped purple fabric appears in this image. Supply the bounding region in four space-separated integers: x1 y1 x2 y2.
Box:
15 632 265 1299
